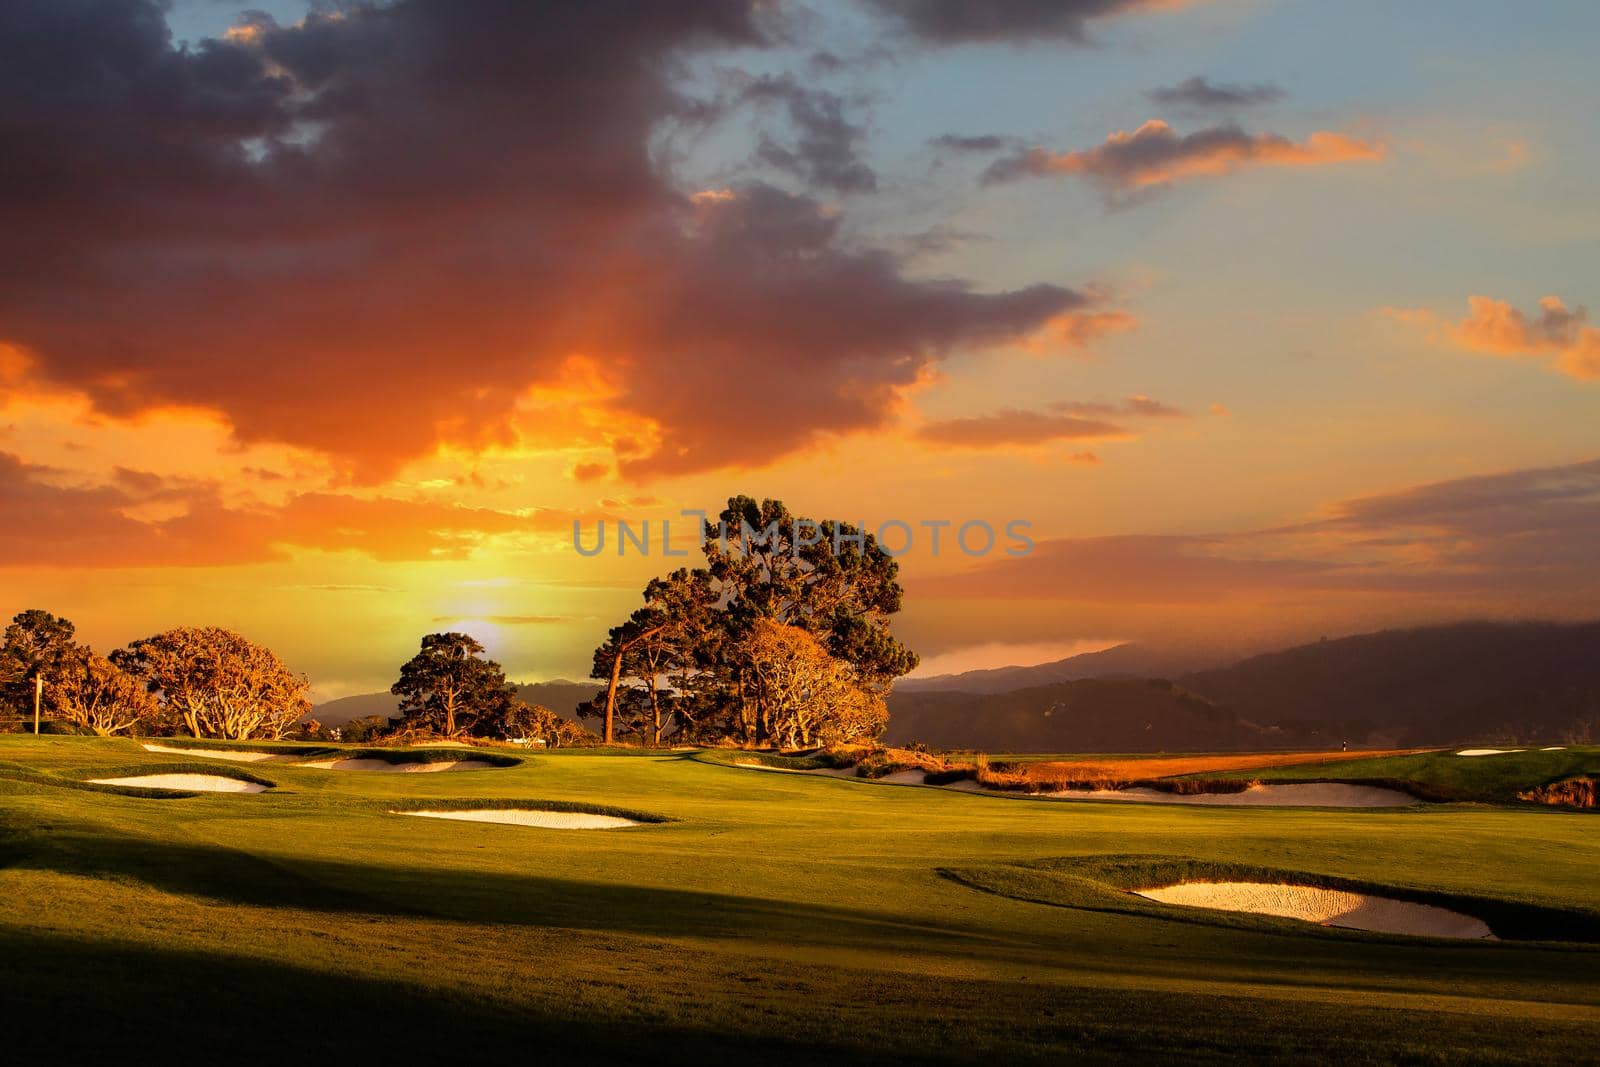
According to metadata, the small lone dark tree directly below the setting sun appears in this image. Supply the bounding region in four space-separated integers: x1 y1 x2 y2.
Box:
389 633 517 737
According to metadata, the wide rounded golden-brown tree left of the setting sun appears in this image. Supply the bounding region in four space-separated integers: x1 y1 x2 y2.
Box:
112 625 310 741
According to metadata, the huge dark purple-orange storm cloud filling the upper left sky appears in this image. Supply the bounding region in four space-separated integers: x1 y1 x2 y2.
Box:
0 0 1086 478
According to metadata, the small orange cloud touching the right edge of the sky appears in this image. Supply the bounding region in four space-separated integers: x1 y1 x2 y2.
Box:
1386 296 1600 381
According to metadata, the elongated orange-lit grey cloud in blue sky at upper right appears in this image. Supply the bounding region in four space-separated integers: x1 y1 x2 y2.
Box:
984 118 1386 189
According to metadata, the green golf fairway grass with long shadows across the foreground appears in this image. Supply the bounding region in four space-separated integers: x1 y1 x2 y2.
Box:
0 736 1600 1064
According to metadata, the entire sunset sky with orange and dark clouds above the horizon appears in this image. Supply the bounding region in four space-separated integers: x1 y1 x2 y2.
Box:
0 0 1600 699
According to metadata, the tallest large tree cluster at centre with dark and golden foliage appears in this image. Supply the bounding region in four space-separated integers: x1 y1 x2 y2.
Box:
581 496 917 745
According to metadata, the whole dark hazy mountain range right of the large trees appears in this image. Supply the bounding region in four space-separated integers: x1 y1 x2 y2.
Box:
886 622 1600 752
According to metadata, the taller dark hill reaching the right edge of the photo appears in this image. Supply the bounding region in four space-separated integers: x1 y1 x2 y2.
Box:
1181 622 1600 745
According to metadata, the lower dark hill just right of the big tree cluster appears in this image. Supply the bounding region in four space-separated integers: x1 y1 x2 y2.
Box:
885 678 1282 752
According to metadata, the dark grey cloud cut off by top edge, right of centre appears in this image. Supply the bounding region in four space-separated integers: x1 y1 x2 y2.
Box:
864 0 1184 45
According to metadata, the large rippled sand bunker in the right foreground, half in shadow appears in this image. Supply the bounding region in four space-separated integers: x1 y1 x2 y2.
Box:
1138 881 1496 941
